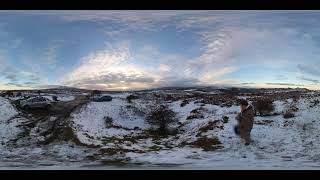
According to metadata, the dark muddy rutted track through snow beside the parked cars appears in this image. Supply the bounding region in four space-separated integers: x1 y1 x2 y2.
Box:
11 96 89 145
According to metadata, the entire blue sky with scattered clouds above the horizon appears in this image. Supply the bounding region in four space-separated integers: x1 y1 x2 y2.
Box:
0 10 320 90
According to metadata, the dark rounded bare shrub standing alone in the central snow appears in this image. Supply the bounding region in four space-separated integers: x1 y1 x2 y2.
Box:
146 105 177 134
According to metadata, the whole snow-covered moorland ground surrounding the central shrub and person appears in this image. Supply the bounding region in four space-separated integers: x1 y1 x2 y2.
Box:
0 91 320 169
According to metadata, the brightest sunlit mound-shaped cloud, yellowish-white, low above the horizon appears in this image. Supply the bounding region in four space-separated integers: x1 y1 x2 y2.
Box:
61 44 159 89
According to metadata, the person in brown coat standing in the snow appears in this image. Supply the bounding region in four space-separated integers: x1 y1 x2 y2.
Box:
235 100 254 146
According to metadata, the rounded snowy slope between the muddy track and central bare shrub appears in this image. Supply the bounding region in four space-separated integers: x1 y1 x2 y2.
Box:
71 99 148 145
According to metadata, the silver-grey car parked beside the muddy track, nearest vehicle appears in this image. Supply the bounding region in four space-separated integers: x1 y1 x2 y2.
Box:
20 97 51 110
